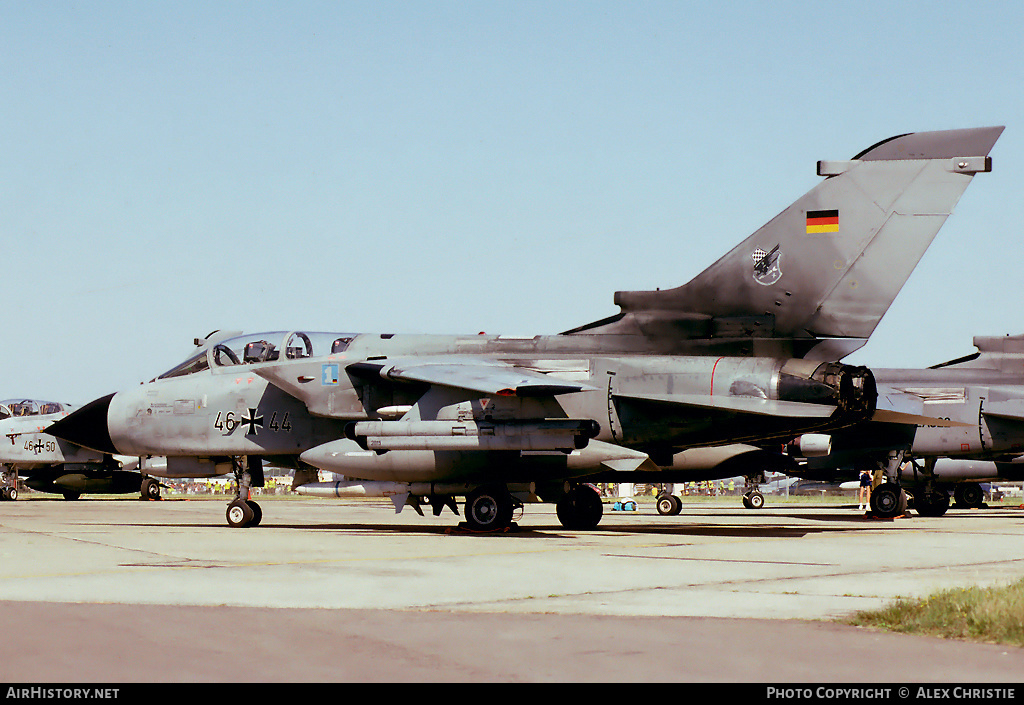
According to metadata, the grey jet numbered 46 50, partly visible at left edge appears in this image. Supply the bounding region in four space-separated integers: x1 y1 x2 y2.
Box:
0 399 160 500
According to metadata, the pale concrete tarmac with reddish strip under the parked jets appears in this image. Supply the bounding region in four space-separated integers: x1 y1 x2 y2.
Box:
0 494 1024 693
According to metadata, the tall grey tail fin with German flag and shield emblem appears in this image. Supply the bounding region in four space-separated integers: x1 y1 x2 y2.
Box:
566 127 1004 359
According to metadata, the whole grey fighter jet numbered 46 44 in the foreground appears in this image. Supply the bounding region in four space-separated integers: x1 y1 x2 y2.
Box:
48 127 1002 529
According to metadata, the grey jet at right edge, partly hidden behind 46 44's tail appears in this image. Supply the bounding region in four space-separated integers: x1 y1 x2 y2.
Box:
792 335 1024 516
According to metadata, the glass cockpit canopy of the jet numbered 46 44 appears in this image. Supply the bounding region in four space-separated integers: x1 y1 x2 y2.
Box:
157 331 355 379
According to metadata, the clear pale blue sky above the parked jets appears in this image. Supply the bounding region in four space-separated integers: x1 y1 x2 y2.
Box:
0 0 1024 403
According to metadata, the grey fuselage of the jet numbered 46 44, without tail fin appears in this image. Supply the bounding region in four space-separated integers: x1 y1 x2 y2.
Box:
49 333 873 482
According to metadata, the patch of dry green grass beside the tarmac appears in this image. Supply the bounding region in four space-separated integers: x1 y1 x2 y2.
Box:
847 580 1024 647
